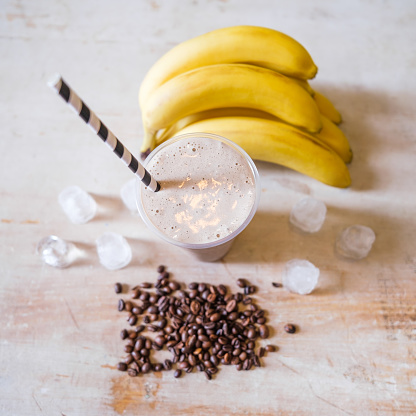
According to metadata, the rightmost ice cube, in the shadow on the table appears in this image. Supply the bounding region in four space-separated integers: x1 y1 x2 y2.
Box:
335 225 376 260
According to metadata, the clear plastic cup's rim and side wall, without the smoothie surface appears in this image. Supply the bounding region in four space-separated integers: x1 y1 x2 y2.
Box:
136 133 260 262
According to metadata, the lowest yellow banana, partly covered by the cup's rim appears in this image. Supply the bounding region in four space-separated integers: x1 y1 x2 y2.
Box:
171 117 351 188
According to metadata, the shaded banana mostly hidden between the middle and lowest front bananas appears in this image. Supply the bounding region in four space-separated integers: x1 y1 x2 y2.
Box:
156 107 352 163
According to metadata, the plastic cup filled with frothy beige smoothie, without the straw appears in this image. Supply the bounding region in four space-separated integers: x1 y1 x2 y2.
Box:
137 133 260 261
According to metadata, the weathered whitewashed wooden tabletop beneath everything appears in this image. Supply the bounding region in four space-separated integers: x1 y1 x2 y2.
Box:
0 0 416 416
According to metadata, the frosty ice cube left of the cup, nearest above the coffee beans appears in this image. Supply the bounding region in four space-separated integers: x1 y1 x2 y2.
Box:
95 232 132 270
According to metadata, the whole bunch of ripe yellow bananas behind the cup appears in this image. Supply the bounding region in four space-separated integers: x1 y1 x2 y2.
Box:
139 26 352 188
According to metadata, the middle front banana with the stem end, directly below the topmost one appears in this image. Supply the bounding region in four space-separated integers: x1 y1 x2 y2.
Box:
141 64 322 152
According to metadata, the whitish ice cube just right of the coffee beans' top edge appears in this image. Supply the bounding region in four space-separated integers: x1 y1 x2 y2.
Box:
282 259 319 295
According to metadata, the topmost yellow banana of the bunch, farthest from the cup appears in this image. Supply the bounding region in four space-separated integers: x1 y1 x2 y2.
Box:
139 26 318 108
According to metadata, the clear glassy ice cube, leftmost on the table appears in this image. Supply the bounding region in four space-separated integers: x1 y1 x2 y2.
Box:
36 235 78 269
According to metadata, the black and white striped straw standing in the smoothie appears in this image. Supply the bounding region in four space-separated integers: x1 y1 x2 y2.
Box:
48 74 160 192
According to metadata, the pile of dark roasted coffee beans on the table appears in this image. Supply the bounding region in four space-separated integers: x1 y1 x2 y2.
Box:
114 266 276 380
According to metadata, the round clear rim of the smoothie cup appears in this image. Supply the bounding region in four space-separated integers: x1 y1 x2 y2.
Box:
135 132 261 250
